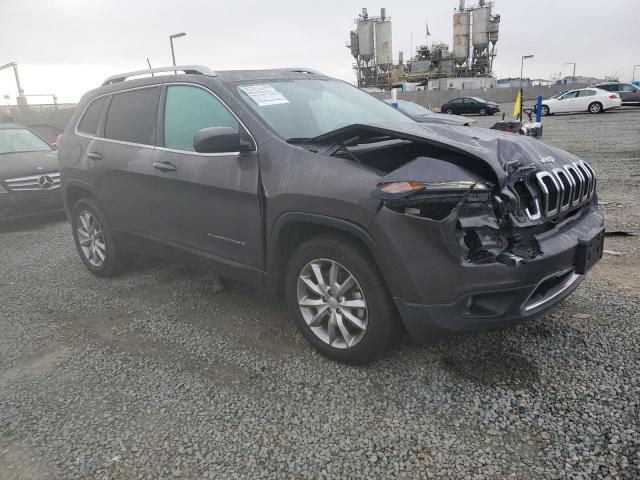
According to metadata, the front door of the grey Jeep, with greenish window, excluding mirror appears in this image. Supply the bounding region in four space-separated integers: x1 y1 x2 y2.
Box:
153 84 263 273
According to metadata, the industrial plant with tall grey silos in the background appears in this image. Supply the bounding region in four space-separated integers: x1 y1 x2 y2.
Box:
347 0 500 90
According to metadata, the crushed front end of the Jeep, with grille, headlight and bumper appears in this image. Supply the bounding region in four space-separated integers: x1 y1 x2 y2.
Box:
370 152 604 339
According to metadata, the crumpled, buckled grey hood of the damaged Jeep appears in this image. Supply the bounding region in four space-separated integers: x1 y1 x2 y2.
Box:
314 122 580 185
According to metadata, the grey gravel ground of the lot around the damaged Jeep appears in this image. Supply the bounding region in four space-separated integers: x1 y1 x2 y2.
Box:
0 107 640 480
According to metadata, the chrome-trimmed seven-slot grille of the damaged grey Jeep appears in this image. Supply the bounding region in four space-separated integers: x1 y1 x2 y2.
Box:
523 160 596 220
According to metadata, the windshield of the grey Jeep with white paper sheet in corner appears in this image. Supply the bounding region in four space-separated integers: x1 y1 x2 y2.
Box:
237 79 414 140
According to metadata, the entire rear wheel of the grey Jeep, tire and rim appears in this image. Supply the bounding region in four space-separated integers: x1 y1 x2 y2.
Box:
71 198 125 277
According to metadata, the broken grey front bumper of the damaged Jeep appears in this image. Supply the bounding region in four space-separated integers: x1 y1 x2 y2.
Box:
371 202 604 340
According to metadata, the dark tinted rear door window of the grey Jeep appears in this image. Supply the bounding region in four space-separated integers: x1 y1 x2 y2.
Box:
104 87 160 145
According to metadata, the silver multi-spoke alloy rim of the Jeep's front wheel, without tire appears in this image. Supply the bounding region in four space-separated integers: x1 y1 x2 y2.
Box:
297 258 368 349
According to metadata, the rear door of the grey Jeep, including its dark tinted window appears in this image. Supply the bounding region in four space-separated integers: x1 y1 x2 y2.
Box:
86 85 163 242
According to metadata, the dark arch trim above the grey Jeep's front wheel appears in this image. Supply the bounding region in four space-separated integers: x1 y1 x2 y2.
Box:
265 212 397 296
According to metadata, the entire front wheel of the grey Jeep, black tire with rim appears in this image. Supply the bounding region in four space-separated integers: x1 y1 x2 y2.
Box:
285 234 400 365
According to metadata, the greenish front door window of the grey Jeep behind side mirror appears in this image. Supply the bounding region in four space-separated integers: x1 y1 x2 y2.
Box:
164 85 239 151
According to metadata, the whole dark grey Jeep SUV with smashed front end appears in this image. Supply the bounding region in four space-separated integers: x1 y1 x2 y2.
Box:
59 66 603 363
